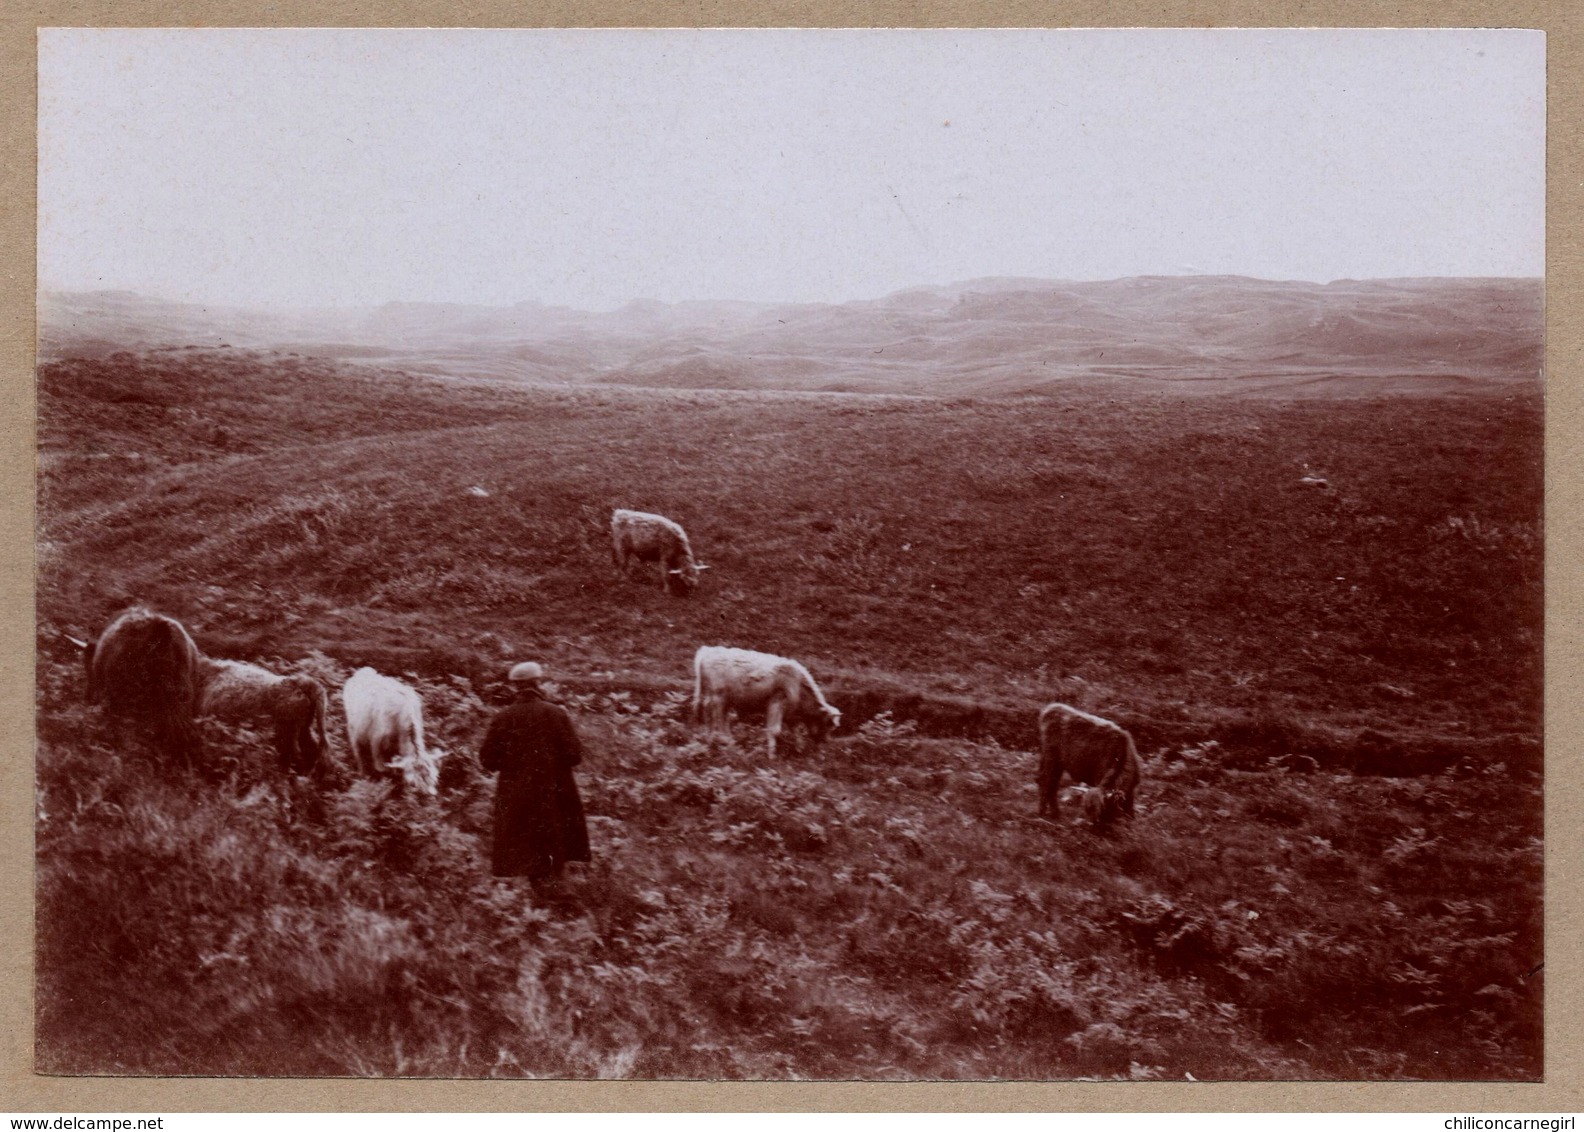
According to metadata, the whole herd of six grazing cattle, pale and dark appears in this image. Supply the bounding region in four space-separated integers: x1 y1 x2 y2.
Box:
76 510 1139 826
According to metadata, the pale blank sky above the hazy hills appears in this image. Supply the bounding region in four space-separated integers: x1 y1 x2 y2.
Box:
38 28 1544 310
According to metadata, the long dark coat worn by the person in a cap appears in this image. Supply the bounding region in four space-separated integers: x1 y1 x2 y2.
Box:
478 692 589 877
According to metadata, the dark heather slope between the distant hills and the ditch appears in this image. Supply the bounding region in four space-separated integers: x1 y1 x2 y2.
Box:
40 351 1541 747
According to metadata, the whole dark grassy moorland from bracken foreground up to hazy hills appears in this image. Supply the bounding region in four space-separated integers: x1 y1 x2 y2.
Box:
38 350 1543 1080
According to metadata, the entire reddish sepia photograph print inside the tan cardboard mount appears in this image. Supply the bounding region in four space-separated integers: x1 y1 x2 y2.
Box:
32 27 1554 1083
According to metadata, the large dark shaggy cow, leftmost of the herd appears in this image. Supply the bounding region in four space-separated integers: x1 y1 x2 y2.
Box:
82 606 201 765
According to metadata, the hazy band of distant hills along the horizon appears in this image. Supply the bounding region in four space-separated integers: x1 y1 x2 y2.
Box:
40 275 1544 396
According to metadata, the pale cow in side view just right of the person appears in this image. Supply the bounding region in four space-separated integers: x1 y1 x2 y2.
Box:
692 644 841 758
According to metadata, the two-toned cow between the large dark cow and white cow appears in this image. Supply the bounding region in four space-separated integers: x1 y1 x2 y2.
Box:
198 657 328 774
